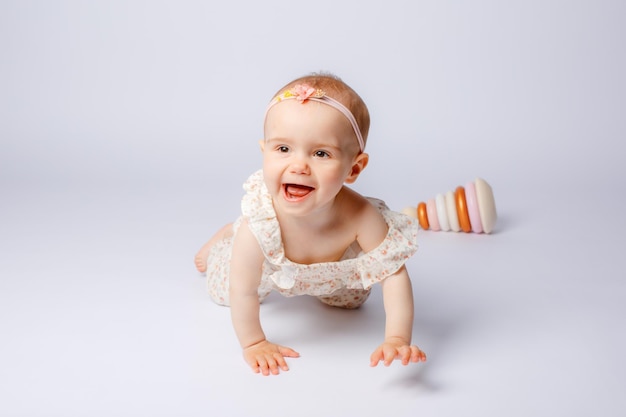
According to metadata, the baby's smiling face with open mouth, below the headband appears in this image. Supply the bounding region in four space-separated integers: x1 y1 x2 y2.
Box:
262 100 359 215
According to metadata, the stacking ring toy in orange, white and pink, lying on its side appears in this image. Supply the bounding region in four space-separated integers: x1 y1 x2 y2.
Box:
403 178 498 234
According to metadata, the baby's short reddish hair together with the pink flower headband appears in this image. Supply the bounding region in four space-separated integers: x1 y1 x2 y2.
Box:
268 73 370 152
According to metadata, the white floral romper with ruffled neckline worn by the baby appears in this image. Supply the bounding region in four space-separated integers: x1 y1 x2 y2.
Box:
206 170 418 308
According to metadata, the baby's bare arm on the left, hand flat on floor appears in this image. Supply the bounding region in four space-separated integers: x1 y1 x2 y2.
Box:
230 221 300 375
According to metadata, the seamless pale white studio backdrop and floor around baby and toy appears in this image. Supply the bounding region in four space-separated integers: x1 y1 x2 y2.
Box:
0 0 626 416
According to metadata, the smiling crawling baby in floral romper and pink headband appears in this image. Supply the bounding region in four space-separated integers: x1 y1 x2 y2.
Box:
195 75 426 375
